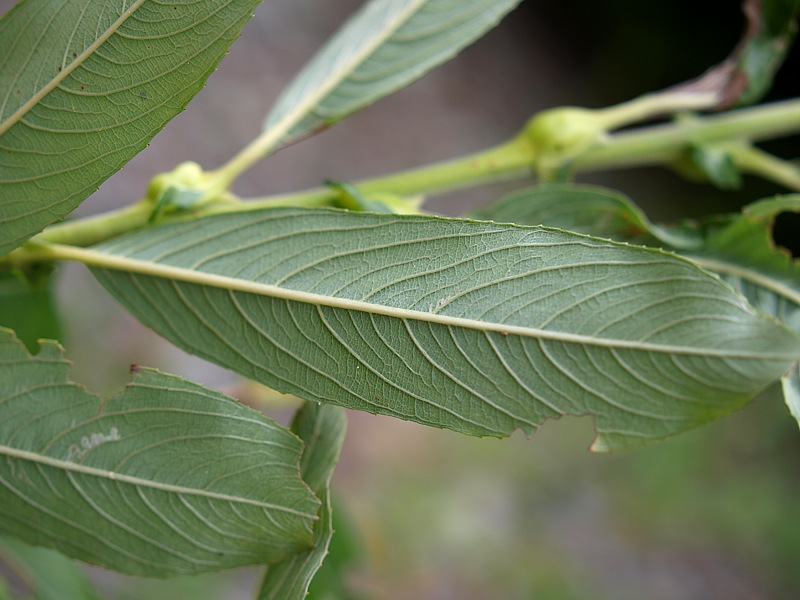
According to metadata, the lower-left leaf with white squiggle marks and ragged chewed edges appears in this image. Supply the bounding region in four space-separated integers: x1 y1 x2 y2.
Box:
0 330 319 576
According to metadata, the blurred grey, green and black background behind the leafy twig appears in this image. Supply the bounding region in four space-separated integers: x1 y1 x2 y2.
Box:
0 0 800 600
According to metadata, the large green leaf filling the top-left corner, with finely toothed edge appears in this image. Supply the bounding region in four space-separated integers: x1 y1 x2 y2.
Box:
0 0 258 255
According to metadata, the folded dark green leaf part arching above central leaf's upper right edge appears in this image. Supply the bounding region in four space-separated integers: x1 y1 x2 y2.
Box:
472 183 700 249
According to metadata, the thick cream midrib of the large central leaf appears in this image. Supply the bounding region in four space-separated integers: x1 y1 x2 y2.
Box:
47 244 797 360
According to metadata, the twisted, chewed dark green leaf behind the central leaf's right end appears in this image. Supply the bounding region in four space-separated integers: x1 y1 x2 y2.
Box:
477 184 800 428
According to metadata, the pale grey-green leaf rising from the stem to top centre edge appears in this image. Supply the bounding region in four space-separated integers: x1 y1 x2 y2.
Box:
264 0 520 144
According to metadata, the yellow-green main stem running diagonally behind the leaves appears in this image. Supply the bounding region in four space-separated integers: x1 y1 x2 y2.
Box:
10 100 800 255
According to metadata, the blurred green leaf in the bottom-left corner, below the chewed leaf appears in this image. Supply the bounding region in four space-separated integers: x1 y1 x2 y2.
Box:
0 538 100 600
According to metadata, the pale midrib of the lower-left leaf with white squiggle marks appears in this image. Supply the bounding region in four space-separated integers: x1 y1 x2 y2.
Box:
0 445 316 519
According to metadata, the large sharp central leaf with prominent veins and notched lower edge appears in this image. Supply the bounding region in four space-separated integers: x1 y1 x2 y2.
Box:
76 209 800 450
